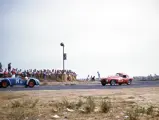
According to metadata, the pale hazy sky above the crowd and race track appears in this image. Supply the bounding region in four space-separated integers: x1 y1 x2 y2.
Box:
0 0 159 78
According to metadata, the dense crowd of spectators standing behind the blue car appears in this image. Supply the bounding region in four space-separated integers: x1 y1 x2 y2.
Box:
0 63 77 80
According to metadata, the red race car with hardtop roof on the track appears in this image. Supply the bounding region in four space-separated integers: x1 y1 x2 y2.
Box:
101 73 133 86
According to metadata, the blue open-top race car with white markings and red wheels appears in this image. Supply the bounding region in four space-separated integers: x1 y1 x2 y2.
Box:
0 76 40 88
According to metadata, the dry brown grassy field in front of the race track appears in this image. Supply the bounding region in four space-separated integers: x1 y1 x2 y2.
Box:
0 87 159 120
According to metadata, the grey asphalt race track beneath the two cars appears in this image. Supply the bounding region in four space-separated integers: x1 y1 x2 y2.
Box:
0 81 159 91
